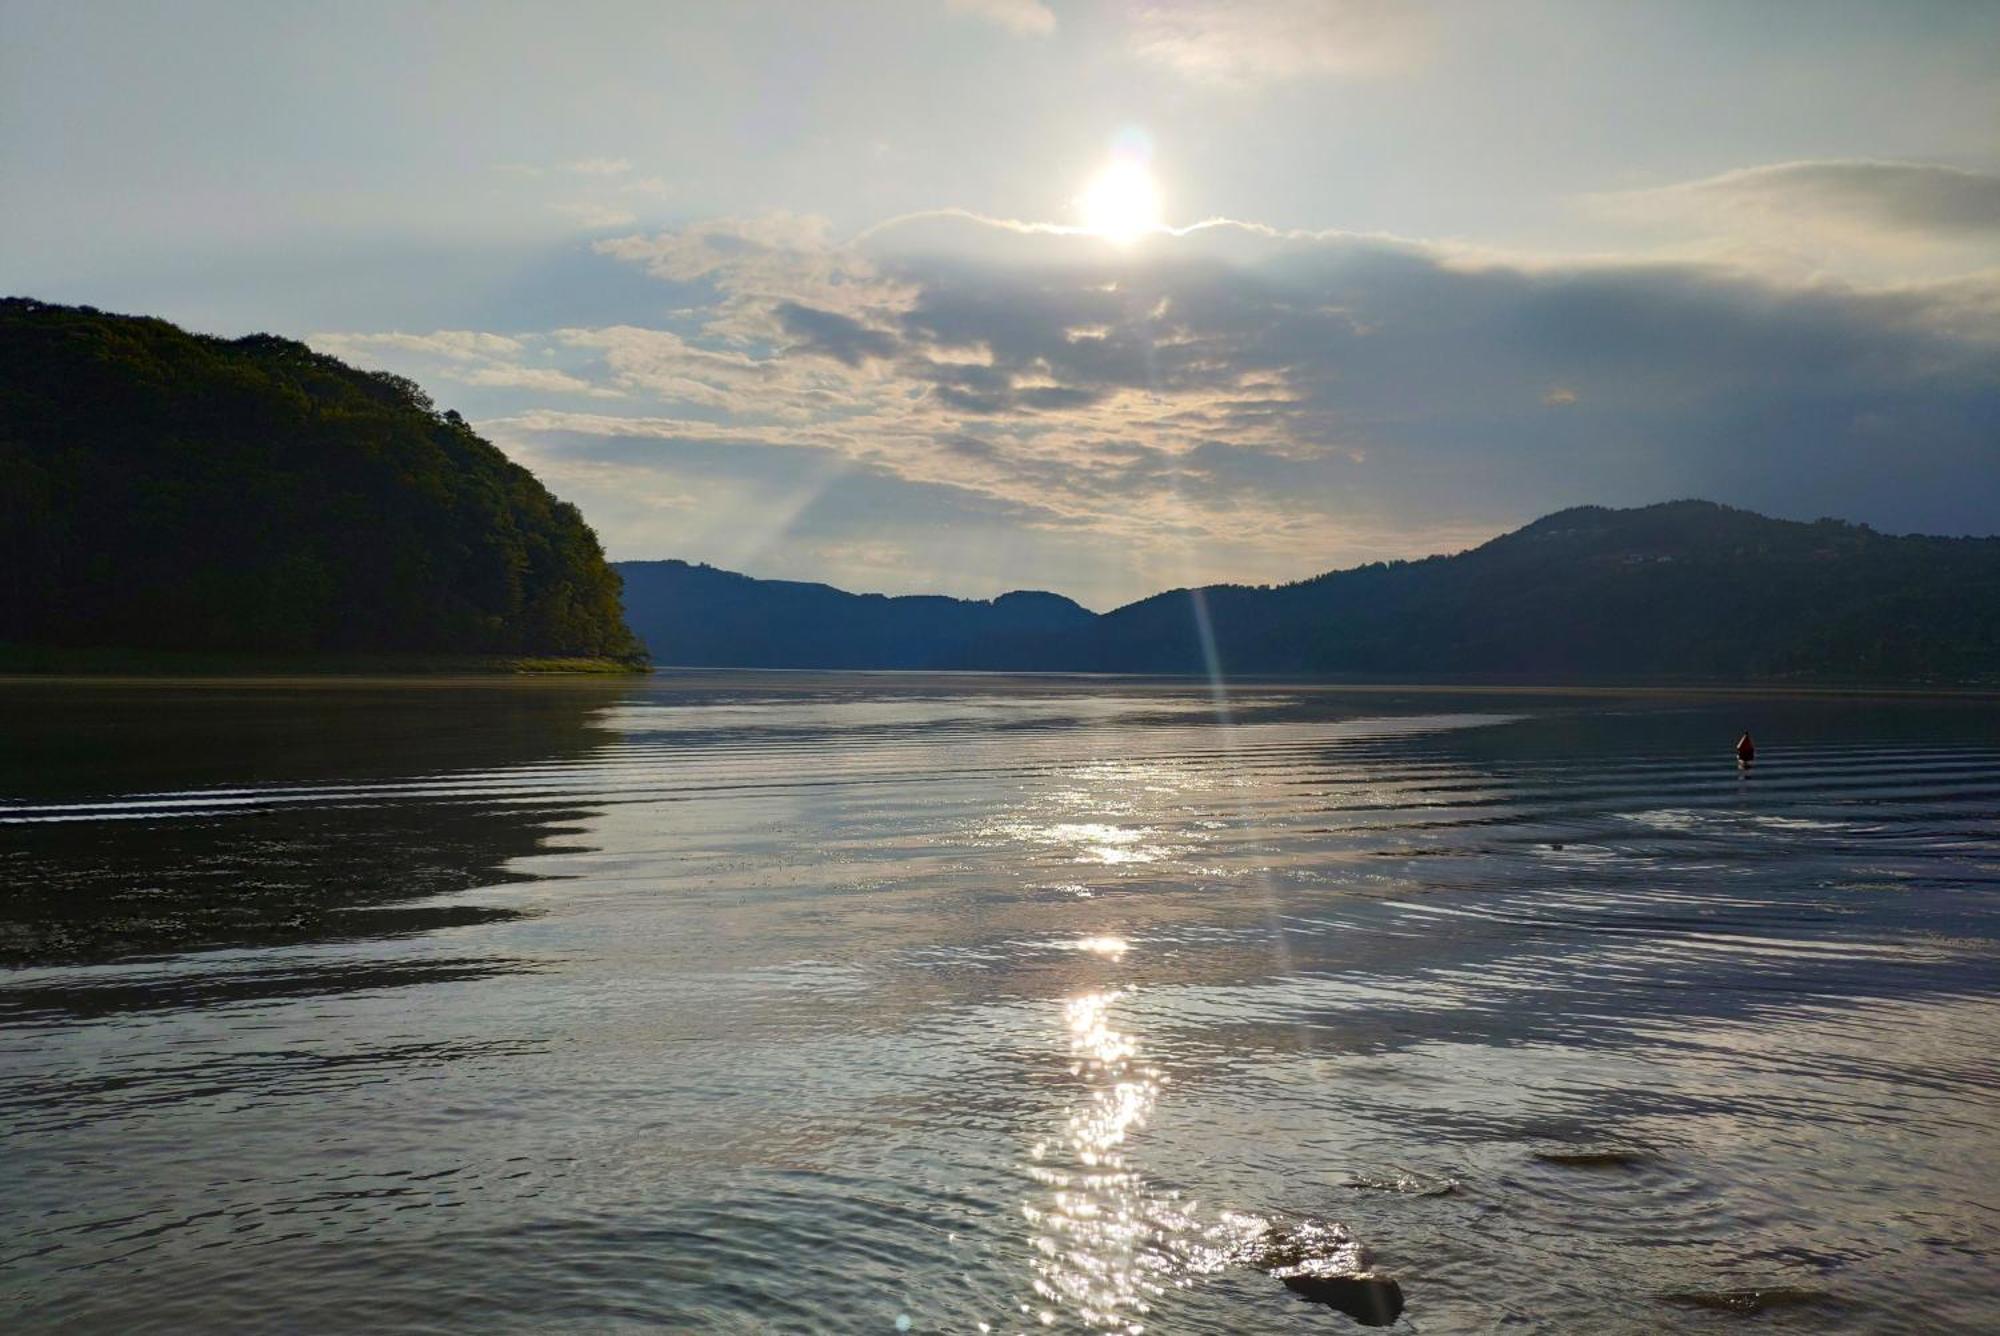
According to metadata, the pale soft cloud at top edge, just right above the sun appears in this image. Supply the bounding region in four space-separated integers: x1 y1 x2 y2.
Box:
1132 0 1432 88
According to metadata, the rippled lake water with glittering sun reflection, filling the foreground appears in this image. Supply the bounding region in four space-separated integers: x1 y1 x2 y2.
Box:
0 674 2000 1332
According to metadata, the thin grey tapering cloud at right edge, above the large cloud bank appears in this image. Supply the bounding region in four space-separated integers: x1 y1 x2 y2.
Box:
1596 160 2000 240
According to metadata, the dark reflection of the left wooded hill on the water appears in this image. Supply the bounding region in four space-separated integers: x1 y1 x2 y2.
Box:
0 682 616 964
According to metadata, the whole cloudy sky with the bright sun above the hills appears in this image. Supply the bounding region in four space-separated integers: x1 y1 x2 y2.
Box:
0 0 2000 608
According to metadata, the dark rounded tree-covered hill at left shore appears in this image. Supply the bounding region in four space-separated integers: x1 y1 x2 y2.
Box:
0 298 640 660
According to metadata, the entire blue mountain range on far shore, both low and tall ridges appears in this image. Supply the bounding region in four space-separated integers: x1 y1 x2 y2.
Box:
622 502 2000 682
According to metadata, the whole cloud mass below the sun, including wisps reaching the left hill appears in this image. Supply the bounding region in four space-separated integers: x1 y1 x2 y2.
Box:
320 214 2000 602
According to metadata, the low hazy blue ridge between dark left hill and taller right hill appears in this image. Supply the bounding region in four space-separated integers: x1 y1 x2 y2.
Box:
616 562 1096 668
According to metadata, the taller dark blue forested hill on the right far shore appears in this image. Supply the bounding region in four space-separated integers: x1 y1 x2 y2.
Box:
1070 502 2000 684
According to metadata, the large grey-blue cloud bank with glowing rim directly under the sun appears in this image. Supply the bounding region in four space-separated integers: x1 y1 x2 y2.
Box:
612 218 2000 538
